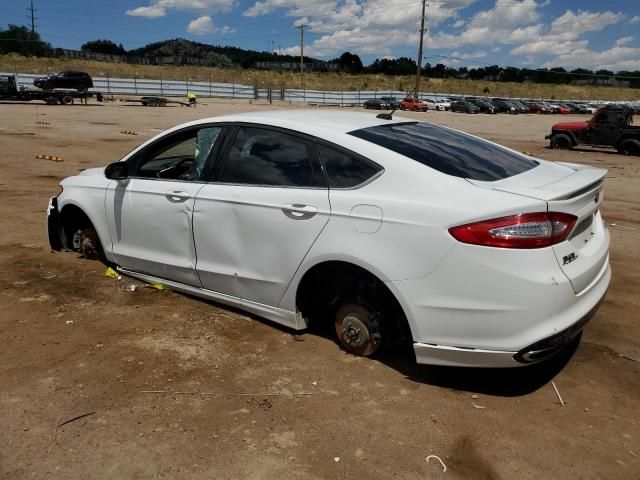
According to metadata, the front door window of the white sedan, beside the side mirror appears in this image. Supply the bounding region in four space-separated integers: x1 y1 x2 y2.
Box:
134 127 222 181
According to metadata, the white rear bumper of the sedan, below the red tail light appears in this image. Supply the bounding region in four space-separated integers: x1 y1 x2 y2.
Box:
396 240 611 367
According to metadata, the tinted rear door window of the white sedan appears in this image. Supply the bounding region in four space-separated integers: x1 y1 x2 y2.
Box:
221 127 323 187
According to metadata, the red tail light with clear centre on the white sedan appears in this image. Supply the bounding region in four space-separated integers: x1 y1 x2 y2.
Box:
449 212 577 248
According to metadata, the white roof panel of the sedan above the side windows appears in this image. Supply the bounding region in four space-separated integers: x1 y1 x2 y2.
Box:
181 109 416 136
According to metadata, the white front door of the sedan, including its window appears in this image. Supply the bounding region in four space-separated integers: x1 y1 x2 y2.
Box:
106 126 222 286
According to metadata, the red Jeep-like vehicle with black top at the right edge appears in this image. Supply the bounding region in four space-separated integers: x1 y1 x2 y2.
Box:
545 104 640 155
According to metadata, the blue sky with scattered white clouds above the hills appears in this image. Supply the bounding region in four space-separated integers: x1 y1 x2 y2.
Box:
0 0 640 70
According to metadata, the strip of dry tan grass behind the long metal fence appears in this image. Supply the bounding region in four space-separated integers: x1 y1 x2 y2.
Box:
0 54 640 100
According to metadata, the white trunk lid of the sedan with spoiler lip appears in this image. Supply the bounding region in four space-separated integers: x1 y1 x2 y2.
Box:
469 162 609 293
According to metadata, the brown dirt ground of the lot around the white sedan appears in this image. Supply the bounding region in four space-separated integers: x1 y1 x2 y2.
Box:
0 100 640 480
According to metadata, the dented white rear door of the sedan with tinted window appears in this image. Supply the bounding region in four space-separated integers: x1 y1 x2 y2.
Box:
193 126 330 306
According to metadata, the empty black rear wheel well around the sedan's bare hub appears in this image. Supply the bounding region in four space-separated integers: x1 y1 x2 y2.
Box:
296 261 412 342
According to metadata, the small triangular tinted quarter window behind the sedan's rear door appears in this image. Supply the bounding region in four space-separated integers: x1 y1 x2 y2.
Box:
319 145 382 188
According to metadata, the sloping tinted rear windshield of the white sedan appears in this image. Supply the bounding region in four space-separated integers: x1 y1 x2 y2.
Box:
349 122 539 182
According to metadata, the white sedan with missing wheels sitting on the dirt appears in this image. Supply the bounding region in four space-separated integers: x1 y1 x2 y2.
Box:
48 110 611 367
